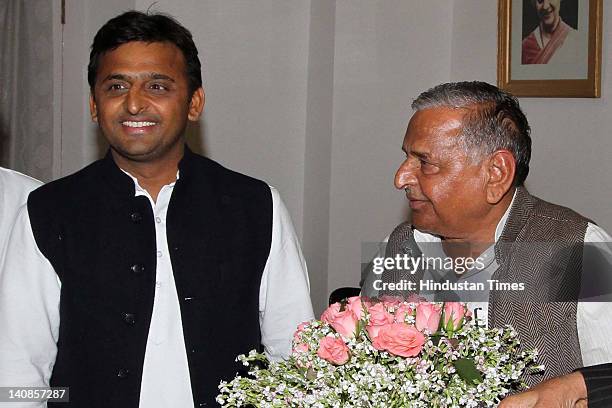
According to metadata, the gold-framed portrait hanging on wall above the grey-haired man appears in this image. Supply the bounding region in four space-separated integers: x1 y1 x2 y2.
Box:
497 0 603 98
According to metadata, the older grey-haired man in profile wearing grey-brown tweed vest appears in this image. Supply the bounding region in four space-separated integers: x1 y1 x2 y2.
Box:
363 82 612 385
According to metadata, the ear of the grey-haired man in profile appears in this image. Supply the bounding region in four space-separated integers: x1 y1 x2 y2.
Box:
485 150 516 205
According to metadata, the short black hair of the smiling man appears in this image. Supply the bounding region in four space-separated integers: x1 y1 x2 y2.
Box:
87 11 202 95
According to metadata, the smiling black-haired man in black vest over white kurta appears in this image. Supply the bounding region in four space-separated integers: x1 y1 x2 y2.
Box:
0 11 312 408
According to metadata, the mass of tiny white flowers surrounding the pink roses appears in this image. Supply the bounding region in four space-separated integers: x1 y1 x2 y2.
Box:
216 304 537 408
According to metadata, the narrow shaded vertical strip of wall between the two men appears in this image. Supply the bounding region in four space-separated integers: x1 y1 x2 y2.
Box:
302 0 336 311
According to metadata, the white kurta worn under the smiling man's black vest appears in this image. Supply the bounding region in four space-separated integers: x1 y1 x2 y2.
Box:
0 173 313 408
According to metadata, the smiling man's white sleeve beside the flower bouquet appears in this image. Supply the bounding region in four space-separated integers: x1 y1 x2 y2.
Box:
259 187 314 360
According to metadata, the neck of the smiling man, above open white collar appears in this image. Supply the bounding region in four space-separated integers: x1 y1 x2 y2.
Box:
112 149 184 201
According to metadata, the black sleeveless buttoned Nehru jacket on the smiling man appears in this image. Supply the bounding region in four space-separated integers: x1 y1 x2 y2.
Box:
28 148 272 408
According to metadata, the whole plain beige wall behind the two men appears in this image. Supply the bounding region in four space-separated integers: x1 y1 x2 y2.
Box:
61 0 612 311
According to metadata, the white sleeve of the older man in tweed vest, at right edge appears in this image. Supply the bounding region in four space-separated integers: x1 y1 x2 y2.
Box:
576 223 612 366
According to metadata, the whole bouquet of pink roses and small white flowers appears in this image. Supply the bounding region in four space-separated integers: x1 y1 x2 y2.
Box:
217 297 543 407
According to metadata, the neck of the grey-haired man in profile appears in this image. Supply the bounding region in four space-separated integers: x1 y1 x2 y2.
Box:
441 188 515 258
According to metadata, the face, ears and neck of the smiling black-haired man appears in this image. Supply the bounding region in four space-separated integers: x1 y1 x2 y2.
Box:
90 41 204 199
